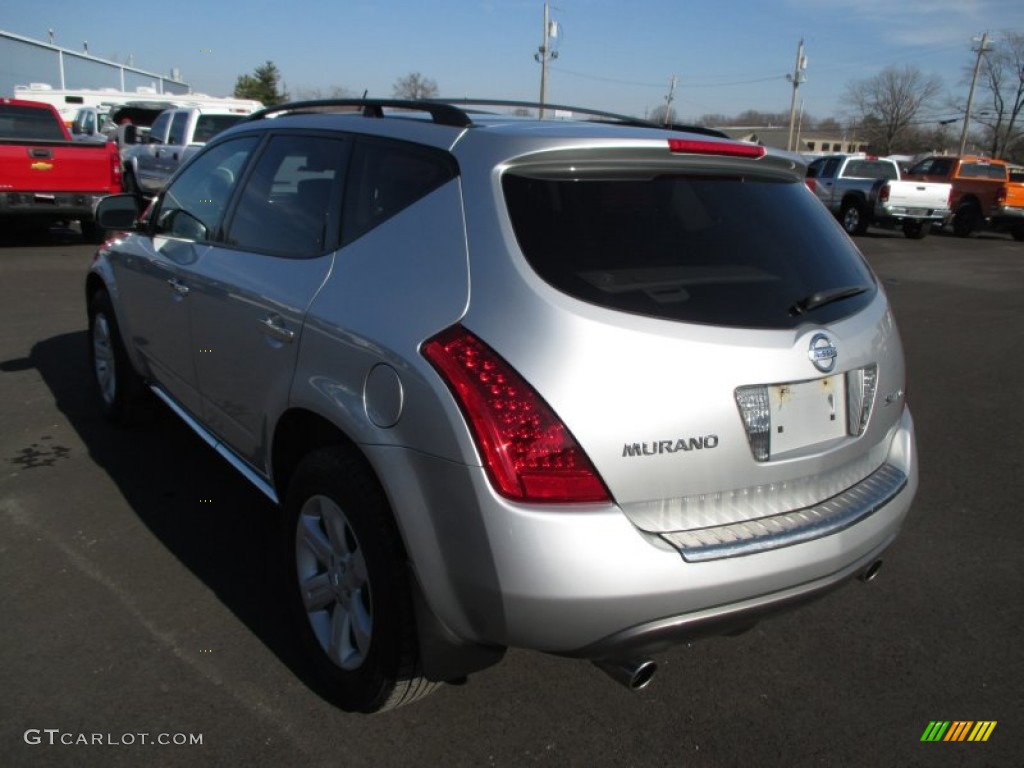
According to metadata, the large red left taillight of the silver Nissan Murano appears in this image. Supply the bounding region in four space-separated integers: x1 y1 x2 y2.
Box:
423 326 611 503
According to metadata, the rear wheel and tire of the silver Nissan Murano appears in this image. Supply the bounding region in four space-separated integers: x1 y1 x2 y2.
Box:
285 447 439 713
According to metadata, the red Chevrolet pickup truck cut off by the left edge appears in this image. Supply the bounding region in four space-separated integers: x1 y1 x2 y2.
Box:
0 98 121 242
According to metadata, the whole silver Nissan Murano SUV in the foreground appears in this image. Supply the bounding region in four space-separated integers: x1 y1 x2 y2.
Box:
85 99 918 712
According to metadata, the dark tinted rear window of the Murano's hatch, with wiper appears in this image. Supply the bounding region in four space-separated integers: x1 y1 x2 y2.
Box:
503 172 877 329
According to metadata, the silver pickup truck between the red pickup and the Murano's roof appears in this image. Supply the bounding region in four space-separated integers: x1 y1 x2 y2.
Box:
121 106 248 197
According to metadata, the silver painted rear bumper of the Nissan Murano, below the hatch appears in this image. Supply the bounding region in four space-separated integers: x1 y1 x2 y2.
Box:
369 412 918 658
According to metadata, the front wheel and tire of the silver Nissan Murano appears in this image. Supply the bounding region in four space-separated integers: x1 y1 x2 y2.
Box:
89 290 146 426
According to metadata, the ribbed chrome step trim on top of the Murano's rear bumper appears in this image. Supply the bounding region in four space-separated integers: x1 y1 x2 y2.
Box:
659 464 907 562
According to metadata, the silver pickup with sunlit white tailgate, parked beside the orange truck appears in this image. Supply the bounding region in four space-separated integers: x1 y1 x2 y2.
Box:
807 155 952 240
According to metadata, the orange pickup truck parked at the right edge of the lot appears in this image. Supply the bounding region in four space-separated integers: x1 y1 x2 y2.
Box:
904 155 1024 241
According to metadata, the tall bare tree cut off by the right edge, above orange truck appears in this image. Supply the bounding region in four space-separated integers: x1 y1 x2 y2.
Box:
971 32 1024 161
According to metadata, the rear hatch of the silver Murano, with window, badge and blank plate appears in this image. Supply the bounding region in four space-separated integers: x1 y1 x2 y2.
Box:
465 140 905 561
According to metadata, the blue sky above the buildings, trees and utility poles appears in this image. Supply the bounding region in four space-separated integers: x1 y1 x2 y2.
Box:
0 0 1024 120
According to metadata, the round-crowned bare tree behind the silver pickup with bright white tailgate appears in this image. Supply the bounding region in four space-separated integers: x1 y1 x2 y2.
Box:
845 65 942 155
